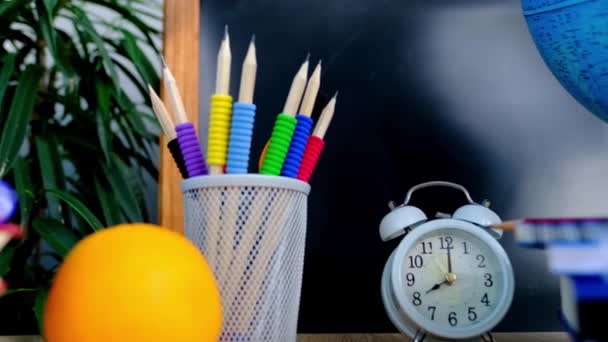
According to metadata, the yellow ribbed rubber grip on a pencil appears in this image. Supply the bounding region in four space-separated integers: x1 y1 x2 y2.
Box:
207 94 232 166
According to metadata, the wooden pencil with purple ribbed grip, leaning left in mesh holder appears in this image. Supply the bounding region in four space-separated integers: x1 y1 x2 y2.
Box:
162 59 208 177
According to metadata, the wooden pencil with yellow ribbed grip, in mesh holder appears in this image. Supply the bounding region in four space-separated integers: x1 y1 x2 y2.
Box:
207 26 232 175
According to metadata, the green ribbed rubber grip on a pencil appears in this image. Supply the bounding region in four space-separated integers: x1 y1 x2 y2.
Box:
260 113 297 176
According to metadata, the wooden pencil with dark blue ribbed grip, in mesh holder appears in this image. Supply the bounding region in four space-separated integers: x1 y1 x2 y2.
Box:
281 61 321 178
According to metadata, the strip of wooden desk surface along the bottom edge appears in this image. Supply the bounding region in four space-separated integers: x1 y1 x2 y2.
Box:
0 333 568 342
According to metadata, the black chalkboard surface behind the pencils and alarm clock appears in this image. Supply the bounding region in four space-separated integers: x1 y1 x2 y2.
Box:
200 0 608 332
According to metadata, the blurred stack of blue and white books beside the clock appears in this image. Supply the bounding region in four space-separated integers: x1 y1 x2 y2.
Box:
515 218 608 341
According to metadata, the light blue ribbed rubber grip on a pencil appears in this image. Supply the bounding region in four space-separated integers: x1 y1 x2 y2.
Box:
226 102 256 174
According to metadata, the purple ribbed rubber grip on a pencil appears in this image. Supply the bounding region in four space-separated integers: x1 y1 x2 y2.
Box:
175 122 208 177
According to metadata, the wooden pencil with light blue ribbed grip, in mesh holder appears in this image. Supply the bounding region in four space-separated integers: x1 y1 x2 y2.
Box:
226 36 258 174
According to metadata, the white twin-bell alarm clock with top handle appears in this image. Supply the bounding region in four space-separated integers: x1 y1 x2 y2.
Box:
380 181 514 342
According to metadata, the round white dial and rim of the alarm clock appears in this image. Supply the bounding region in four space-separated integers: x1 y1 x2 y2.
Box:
392 219 514 338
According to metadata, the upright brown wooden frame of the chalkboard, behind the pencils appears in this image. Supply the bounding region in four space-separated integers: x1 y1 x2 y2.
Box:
158 0 200 233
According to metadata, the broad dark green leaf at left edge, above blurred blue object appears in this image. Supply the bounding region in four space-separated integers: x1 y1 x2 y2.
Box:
0 65 42 178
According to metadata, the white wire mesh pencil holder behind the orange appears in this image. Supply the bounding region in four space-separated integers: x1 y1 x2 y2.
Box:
181 175 310 342
